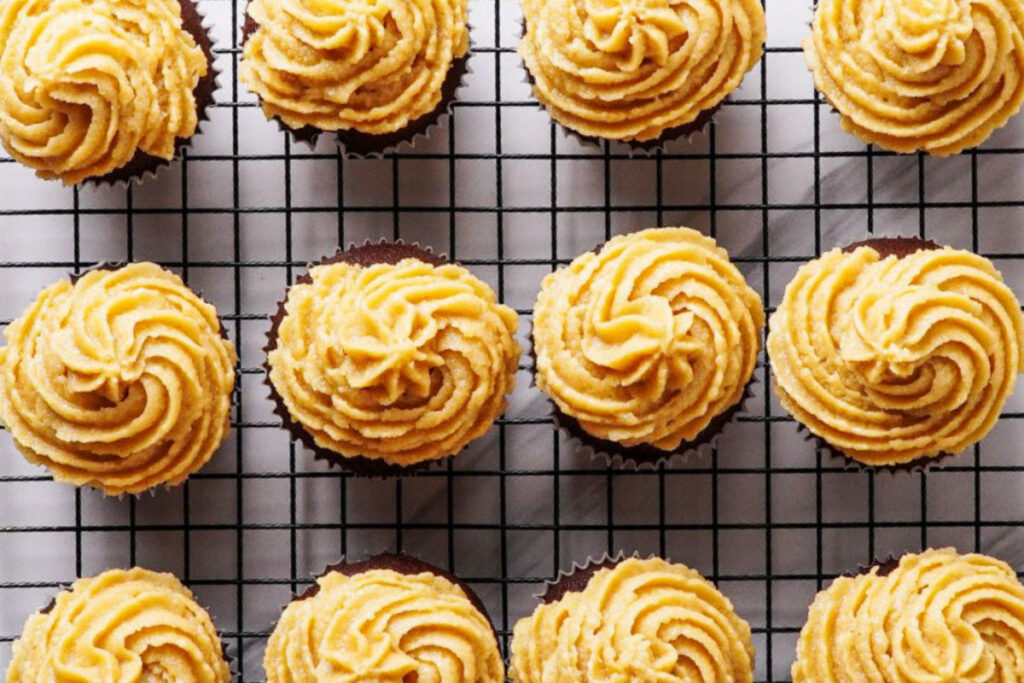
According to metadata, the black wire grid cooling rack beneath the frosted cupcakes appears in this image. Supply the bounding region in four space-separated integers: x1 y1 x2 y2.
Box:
6 0 1024 681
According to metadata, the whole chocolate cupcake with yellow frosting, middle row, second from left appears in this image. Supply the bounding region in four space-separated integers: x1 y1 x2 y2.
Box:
266 243 519 475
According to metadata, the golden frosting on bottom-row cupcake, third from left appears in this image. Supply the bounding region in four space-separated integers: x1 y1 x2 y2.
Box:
511 558 754 683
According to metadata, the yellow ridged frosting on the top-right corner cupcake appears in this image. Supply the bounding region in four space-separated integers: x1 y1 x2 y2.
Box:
804 0 1024 155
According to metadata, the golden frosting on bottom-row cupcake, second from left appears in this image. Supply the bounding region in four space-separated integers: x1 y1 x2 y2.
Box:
263 569 505 683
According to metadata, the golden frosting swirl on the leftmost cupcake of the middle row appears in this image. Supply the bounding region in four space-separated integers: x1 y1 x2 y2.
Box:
0 263 237 495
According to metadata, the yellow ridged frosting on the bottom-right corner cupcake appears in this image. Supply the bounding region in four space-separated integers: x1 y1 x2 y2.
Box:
793 548 1024 683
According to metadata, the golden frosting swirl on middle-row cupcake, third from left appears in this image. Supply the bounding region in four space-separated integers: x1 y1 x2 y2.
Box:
534 227 765 451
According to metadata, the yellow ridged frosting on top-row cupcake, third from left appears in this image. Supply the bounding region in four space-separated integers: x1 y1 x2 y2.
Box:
519 0 765 141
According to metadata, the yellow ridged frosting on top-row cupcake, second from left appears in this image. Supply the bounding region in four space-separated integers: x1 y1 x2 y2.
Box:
239 0 469 135
